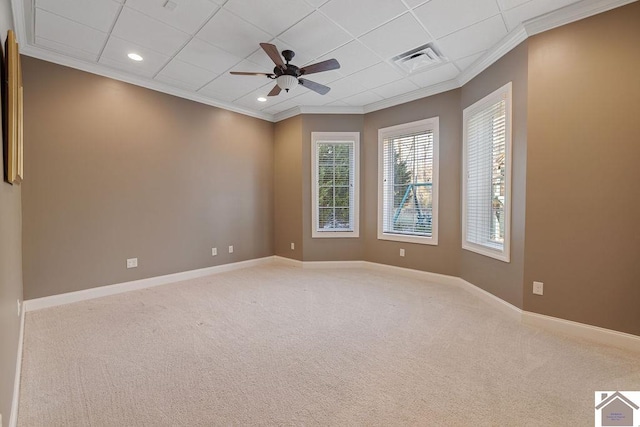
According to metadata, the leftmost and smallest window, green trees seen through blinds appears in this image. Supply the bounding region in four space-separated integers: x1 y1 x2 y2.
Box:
311 132 360 237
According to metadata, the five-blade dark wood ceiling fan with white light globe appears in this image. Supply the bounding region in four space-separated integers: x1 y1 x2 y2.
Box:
231 43 340 96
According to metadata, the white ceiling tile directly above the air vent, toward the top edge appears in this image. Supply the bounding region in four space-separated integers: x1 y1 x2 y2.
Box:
360 13 431 59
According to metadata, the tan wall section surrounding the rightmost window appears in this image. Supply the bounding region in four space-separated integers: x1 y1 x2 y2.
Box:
458 41 528 308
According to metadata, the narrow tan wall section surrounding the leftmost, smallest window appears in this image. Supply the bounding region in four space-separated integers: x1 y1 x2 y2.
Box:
302 114 365 261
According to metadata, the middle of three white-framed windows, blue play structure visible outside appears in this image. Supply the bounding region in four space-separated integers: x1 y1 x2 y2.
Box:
378 117 438 245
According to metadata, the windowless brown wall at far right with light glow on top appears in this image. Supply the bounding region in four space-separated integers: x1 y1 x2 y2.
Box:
524 3 640 335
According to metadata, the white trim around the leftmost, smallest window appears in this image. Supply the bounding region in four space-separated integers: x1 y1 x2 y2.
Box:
311 132 360 238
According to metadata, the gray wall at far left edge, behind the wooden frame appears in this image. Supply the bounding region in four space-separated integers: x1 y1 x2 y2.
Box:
0 0 23 426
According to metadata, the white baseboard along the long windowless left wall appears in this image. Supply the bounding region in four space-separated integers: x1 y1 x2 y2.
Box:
24 256 273 311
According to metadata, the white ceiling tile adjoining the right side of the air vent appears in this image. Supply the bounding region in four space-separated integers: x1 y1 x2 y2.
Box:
438 15 507 61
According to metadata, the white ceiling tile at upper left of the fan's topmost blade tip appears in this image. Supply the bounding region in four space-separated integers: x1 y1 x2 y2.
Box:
197 8 272 58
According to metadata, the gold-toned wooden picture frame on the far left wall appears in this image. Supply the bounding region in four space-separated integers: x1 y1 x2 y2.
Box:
3 30 24 184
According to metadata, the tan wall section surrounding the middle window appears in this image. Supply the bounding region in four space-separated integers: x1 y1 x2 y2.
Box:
361 89 462 276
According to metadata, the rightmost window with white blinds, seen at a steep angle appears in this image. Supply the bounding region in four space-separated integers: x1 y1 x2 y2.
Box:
462 83 511 262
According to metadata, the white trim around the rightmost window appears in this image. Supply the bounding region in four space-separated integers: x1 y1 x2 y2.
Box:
462 82 513 262
